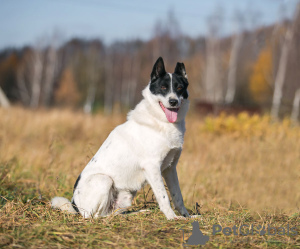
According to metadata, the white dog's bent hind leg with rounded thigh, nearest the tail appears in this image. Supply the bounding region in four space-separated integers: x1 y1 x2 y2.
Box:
73 174 115 218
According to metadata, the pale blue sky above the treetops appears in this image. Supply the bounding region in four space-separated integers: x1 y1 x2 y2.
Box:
0 0 298 49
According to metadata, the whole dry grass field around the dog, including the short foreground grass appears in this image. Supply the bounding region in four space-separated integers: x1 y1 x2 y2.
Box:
0 107 300 248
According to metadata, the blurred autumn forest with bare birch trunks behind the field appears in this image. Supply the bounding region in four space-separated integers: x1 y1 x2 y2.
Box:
0 5 300 120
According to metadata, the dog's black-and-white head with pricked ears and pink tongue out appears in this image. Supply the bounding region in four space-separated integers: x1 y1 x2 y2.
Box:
149 57 189 123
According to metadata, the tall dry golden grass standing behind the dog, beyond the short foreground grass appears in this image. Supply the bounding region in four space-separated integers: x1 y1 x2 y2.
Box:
0 108 300 212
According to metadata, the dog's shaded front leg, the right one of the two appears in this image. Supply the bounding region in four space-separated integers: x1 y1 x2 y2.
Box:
163 160 189 217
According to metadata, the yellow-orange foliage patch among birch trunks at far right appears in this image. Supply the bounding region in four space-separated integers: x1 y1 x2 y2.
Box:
249 46 272 103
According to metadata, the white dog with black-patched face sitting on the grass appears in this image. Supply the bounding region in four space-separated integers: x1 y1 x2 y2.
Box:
51 57 189 220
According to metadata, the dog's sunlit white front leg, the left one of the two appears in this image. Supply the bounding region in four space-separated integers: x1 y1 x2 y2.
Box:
144 165 177 220
